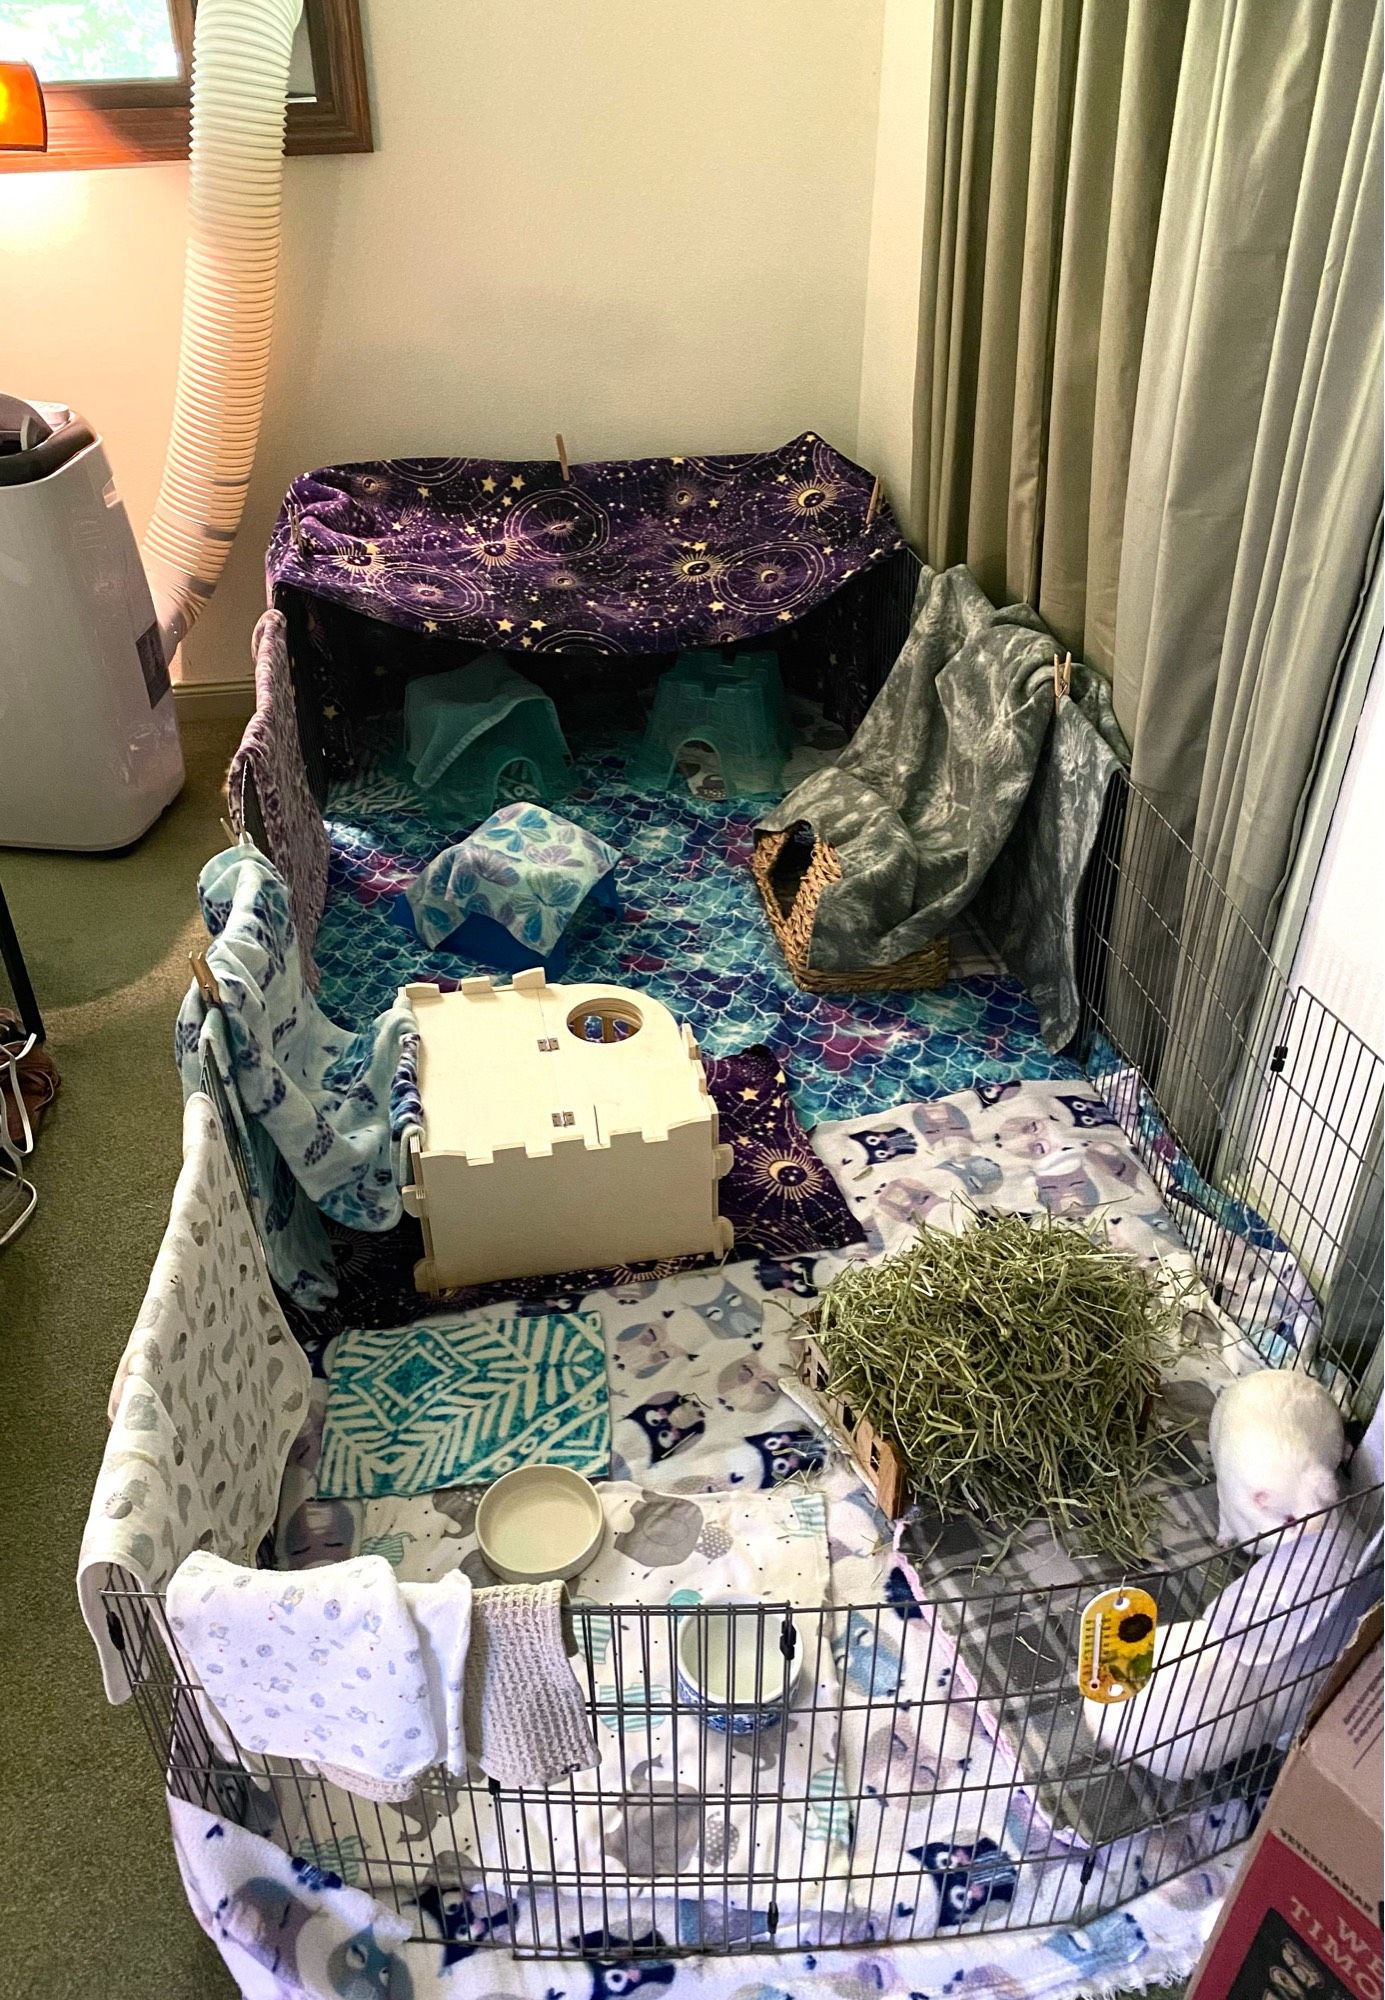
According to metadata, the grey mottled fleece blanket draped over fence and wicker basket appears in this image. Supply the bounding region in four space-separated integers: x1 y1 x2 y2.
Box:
757 566 1129 1048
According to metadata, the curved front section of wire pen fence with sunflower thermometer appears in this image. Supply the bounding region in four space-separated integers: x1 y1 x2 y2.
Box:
106 1496 1375 1958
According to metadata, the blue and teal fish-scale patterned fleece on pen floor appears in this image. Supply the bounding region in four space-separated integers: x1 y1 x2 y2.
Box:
316 736 1081 1126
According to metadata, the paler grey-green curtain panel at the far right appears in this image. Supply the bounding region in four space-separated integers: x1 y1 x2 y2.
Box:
1115 0 1385 936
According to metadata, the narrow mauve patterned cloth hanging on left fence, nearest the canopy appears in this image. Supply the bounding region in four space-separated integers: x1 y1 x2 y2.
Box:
226 612 330 988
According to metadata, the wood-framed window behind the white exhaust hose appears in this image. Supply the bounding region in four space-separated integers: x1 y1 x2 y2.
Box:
0 0 374 172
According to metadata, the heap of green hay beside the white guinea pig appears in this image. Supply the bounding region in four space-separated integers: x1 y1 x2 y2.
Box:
819 1216 1181 1560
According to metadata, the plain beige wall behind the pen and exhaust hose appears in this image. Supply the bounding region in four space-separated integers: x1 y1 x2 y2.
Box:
0 0 888 680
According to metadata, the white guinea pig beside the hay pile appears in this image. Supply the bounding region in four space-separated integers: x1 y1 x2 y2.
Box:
1209 1368 1345 1542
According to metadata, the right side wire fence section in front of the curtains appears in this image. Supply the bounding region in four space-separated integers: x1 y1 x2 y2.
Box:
1079 780 1385 1422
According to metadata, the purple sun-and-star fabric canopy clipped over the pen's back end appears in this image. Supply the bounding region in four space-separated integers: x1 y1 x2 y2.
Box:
268 430 901 654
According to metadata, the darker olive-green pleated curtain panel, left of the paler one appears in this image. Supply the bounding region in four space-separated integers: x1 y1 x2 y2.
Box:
913 0 1189 672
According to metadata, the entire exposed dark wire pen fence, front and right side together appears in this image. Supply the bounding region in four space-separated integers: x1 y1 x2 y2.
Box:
106 716 1381 1960
